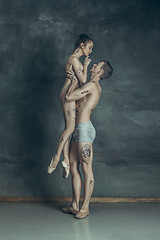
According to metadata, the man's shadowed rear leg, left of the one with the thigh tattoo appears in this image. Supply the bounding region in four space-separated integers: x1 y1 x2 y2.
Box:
63 140 82 214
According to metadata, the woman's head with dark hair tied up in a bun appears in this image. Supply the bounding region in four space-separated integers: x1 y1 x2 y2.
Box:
75 34 93 56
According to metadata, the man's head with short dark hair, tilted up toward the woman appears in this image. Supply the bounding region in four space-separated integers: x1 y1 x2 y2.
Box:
90 60 113 79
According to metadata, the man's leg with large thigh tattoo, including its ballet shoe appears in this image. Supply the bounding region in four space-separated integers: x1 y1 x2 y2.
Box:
76 142 94 218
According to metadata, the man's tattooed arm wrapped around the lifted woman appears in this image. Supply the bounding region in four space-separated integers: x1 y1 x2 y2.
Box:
66 82 95 102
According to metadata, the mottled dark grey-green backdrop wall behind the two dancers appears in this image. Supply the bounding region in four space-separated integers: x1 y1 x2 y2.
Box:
0 0 160 197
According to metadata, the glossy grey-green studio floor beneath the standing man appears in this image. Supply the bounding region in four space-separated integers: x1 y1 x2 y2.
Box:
0 203 160 240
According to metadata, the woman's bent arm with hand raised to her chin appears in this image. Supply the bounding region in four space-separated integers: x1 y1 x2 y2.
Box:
70 57 91 83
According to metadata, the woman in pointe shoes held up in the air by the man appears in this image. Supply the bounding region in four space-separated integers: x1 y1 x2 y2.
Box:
48 34 93 178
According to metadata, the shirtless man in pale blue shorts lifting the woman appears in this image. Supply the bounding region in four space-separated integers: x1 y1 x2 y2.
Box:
63 61 113 218
